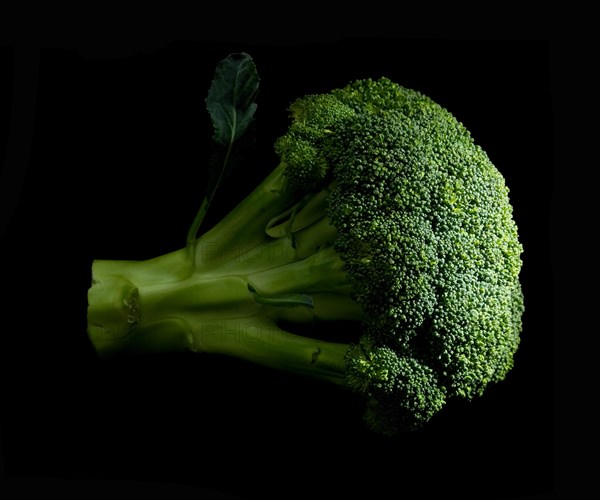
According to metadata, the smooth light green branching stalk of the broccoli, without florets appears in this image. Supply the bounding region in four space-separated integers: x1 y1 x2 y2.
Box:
88 162 362 384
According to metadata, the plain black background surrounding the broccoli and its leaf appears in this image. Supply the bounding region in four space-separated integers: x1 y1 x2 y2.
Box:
0 17 572 499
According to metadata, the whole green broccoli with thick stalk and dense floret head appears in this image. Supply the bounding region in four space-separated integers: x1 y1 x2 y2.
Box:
88 54 524 436
